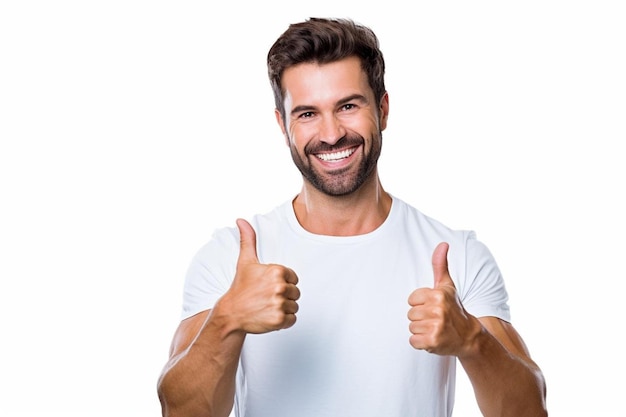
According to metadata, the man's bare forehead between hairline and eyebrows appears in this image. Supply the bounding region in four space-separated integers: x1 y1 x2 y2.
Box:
282 57 372 107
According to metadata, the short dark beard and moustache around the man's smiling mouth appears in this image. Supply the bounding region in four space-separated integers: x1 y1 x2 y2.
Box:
289 132 382 197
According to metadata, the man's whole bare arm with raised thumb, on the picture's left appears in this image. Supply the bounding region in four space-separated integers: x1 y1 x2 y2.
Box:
157 221 300 417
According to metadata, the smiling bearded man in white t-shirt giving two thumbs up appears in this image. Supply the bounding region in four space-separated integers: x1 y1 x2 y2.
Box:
158 19 547 417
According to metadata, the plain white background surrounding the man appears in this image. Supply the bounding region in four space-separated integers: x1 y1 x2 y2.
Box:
0 0 626 417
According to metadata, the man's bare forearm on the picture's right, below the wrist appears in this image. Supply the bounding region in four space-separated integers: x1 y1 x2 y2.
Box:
459 329 547 417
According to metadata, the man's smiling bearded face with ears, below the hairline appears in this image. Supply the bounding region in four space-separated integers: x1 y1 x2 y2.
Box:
276 57 389 196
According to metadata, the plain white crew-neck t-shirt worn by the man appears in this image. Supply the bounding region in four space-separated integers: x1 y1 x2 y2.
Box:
183 197 510 417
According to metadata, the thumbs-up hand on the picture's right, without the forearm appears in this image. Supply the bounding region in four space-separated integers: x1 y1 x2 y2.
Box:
408 242 481 356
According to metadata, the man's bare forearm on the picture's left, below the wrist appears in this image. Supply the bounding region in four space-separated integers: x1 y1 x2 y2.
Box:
158 310 245 417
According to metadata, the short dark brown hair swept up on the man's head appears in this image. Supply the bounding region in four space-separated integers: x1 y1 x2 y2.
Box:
267 18 385 120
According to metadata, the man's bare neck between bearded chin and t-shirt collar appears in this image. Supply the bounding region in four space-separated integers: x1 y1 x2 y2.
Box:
293 171 391 236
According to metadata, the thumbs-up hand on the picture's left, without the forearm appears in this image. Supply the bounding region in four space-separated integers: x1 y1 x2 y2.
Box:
220 219 300 333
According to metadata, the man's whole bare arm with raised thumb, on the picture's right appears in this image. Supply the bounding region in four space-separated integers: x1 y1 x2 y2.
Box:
408 244 547 417
